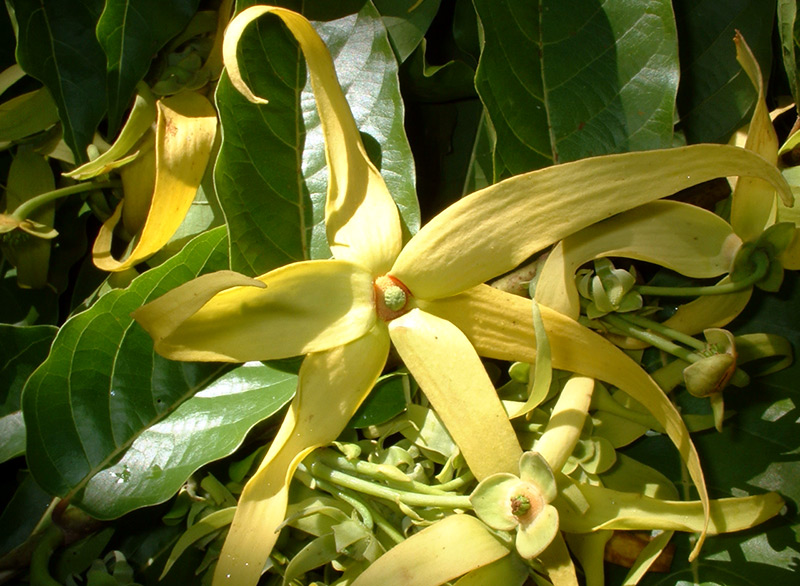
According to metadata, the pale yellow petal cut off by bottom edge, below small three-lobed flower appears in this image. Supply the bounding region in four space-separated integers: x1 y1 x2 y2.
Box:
353 515 510 586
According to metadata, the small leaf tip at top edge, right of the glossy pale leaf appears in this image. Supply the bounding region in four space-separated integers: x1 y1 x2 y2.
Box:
373 0 441 63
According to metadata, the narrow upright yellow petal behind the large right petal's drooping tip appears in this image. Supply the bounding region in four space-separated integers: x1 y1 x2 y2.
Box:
731 31 786 241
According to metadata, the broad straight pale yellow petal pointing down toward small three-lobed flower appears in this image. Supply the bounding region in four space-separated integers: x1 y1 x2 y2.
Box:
389 309 522 480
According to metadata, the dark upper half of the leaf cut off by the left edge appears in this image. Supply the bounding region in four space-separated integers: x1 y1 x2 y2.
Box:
0 324 58 415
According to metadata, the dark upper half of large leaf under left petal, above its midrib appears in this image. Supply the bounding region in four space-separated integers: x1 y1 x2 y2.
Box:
22 228 227 496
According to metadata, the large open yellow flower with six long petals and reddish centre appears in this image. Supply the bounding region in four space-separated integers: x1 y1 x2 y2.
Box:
134 6 782 586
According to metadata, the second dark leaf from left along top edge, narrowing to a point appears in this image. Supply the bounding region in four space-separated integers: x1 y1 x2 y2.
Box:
97 0 199 134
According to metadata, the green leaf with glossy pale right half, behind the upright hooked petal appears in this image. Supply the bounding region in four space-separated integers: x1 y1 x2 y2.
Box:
215 3 419 275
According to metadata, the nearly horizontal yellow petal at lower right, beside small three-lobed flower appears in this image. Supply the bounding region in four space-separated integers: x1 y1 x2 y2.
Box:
554 480 785 535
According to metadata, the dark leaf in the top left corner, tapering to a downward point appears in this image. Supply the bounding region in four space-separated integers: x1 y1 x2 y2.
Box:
8 0 106 162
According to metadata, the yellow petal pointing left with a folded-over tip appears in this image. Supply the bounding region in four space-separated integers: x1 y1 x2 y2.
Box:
133 260 376 362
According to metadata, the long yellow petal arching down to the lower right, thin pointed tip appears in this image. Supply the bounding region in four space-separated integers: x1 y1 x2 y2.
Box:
420 285 708 556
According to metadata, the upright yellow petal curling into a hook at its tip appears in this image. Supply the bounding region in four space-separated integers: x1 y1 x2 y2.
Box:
222 6 402 275
